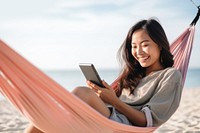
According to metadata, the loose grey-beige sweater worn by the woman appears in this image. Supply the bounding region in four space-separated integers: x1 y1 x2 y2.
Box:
120 67 183 126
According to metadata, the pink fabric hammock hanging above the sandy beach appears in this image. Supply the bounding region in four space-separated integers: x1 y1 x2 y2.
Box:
0 26 195 133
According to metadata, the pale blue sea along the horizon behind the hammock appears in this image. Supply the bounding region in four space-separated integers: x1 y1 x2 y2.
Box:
0 68 200 100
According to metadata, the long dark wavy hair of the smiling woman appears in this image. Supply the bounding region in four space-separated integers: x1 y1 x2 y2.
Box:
118 19 174 95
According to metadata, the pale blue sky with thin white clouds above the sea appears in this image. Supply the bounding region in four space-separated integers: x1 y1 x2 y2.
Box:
0 0 200 70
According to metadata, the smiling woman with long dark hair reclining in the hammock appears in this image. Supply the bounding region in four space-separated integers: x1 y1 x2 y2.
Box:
24 19 182 132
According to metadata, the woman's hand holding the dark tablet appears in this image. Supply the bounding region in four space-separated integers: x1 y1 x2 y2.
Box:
87 80 118 105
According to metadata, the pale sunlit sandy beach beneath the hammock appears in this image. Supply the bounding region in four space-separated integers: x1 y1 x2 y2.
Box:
0 88 200 133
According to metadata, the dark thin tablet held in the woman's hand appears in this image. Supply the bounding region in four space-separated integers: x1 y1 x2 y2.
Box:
79 63 104 87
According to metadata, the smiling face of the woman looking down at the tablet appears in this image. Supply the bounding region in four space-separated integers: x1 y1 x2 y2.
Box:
131 29 162 73
